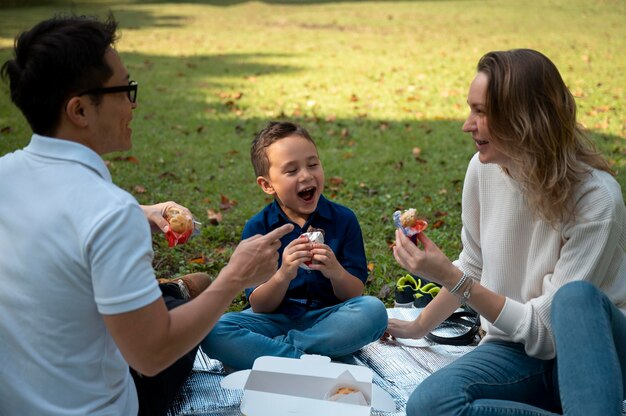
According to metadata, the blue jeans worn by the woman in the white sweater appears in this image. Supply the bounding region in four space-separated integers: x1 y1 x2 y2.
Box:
407 281 626 416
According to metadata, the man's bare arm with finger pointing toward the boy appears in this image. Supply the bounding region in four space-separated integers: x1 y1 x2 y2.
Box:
103 224 293 376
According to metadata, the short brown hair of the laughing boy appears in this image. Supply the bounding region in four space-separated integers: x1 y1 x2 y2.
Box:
250 121 317 176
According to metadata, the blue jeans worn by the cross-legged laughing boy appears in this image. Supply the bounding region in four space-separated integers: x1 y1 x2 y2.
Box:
200 296 387 370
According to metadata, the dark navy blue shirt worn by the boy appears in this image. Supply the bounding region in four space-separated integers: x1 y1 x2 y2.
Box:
242 195 367 318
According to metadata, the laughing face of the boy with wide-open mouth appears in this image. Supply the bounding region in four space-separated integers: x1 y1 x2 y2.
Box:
257 136 324 226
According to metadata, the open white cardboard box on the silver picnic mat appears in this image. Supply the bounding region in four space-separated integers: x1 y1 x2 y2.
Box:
221 355 396 416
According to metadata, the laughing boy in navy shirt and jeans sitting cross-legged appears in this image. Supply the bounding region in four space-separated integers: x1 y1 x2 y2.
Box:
201 122 387 370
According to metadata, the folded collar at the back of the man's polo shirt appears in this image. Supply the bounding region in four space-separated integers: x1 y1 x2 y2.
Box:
24 134 112 182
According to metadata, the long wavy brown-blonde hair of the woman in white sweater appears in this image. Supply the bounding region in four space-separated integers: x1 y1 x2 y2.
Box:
477 49 613 228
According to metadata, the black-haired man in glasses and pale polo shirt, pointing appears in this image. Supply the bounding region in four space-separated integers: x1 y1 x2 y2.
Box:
0 16 291 415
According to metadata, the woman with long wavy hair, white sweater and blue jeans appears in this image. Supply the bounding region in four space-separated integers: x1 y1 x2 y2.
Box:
388 49 626 416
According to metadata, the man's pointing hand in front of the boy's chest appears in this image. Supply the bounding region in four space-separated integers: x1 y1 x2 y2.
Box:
226 224 293 289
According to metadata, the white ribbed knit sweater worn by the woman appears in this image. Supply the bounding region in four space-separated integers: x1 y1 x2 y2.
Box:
455 151 626 359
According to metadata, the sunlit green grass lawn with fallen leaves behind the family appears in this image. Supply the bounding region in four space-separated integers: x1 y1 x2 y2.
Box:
0 0 626 309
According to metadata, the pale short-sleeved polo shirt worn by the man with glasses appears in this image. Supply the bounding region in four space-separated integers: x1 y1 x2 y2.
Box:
0 135 161 416
